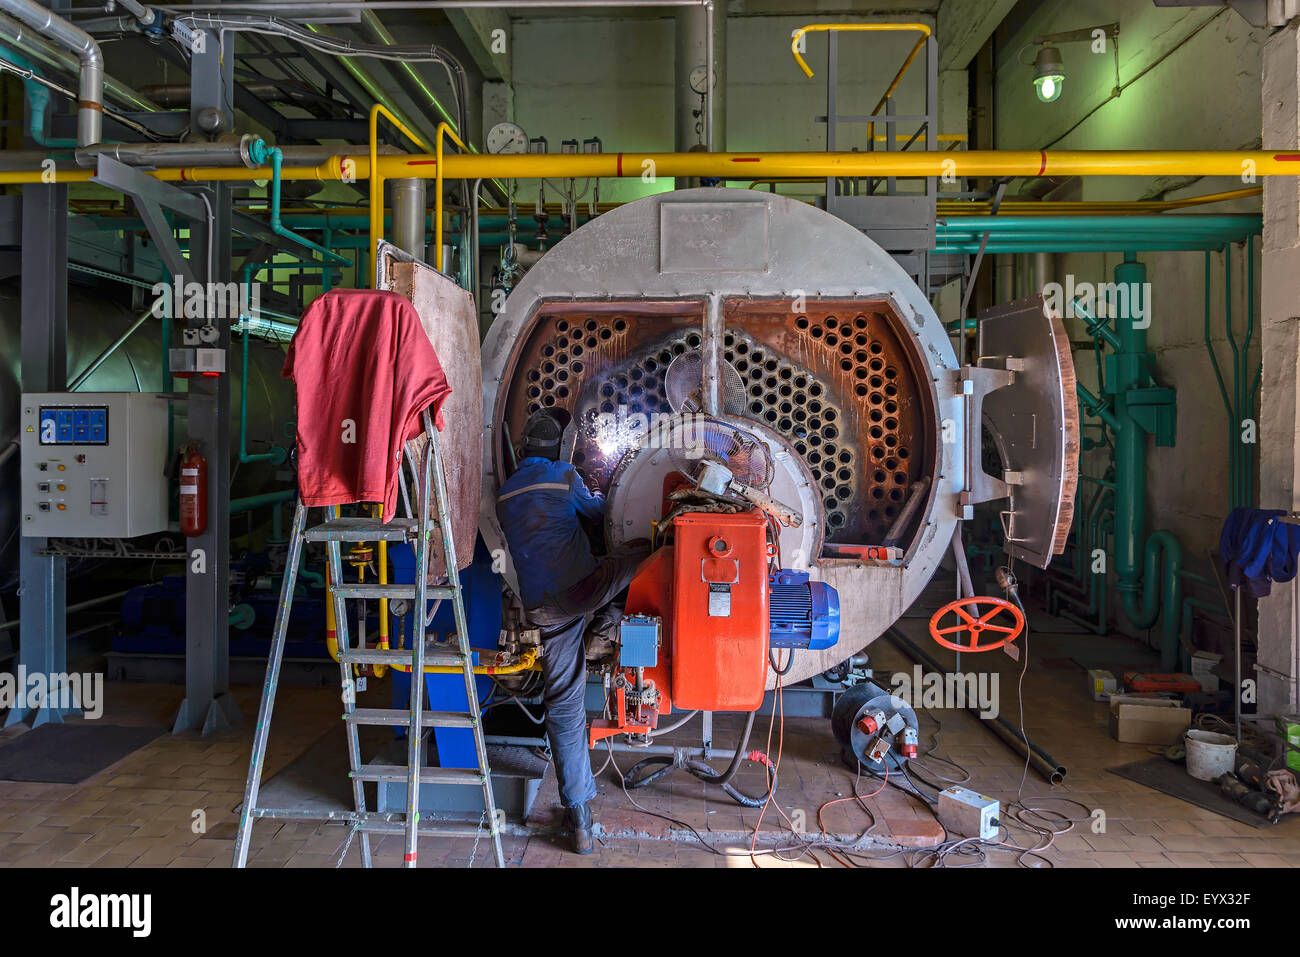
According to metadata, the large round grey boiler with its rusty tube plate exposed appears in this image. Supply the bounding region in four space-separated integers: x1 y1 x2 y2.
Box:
480 190 966 681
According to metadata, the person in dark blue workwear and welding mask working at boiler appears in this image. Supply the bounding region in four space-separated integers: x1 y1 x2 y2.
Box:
497 408 650 854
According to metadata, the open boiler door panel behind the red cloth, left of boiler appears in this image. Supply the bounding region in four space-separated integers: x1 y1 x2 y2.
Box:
376 243 484 579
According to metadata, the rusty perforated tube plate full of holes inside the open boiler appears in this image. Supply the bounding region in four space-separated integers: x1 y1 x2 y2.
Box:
504 299 933 544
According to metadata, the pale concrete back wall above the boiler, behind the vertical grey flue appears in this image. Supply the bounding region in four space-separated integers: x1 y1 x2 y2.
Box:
514 14 933 202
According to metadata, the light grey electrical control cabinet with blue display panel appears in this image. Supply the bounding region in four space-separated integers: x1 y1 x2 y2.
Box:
20 393 168 538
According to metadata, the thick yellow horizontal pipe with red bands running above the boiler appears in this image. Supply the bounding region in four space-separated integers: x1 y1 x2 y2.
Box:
0 150 1300 185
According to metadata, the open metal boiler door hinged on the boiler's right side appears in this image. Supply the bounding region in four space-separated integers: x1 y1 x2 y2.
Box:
979 289 1079 568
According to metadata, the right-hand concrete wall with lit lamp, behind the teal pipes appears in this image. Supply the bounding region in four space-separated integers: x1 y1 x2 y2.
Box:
996 0 1268 634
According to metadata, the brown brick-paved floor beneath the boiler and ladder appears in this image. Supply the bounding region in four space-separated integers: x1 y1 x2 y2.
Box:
0 600 1300 867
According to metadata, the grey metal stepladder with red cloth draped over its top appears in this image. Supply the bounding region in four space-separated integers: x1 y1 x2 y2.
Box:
234 411 504 867
